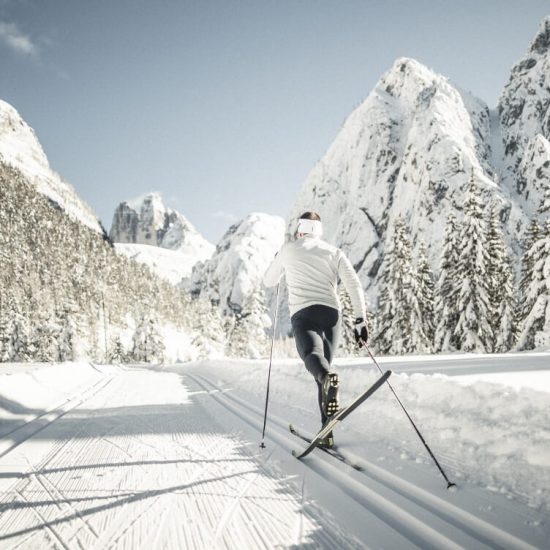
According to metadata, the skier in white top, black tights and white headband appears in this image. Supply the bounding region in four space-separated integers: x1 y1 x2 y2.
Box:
264 212 368 448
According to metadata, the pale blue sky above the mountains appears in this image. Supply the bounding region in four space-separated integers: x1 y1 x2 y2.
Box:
0 0 550 243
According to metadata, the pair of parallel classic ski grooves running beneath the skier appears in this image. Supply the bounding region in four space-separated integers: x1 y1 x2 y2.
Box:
188 374 536 549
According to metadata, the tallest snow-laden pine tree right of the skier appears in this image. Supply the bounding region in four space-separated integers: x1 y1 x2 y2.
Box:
454 175 493 352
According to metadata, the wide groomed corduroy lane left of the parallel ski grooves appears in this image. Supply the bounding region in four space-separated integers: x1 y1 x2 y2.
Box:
0 369 359 550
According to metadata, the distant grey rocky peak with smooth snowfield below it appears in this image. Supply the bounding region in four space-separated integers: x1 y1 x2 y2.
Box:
110 193 214 284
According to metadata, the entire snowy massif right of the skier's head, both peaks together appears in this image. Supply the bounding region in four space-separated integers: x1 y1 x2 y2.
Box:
289 18 550 302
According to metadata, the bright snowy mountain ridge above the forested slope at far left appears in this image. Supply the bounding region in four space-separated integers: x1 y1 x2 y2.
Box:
0 100 105 234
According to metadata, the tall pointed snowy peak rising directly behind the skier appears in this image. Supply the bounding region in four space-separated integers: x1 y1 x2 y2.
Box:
290 58 523 304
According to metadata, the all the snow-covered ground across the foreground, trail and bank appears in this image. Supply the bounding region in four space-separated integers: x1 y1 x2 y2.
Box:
0 353 550 549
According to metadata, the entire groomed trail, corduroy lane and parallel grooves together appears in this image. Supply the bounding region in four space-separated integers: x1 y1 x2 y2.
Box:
0 366 543 550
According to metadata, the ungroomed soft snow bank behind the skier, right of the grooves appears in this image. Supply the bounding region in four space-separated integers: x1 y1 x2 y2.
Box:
187 354 550 510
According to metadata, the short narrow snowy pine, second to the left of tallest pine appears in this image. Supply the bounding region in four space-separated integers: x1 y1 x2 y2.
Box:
411 242 435 353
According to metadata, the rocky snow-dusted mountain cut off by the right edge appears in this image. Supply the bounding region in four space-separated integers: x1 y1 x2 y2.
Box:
496 17 550 216
